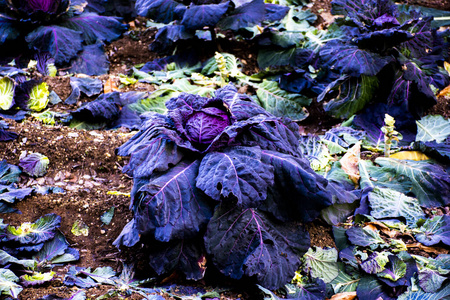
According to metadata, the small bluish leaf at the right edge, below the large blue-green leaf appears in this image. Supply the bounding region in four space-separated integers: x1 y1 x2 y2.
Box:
415 215 450 246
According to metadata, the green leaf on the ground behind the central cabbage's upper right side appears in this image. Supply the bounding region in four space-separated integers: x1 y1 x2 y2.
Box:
256 80 311 121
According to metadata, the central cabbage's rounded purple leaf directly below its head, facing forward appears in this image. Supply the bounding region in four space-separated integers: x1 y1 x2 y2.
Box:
196 146 273 207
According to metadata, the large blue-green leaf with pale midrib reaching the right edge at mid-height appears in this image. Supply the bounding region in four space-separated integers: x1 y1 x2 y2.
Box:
375 157 450 207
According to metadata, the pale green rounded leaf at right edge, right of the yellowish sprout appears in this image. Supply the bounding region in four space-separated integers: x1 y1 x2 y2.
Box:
416 115 450 143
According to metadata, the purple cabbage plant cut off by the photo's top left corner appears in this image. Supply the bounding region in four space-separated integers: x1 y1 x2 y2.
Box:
0 0 126 72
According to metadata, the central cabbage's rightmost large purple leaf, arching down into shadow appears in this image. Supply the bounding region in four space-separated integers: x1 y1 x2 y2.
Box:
262 150 332 222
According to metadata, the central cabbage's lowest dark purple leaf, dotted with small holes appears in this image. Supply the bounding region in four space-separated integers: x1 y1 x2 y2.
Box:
205 206 310 289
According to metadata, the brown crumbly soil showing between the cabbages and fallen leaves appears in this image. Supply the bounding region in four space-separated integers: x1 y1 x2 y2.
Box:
0 0 450 299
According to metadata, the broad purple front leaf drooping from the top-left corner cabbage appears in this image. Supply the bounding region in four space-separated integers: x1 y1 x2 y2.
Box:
25 26 83 64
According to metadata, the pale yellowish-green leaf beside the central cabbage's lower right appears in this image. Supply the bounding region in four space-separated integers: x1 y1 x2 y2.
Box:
303 247 339 283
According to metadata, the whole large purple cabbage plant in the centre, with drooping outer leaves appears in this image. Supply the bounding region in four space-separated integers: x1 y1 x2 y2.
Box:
115 85 331 289
